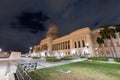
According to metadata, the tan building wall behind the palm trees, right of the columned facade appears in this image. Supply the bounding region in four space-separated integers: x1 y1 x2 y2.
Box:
91 29 120 57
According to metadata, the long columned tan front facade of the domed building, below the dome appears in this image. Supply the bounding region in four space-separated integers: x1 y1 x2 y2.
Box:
34 27 95 56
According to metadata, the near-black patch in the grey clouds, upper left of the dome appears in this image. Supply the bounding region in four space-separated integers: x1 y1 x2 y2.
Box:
12 11 49 33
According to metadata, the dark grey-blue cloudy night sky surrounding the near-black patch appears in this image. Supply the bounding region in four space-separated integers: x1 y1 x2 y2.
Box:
0 0 120 51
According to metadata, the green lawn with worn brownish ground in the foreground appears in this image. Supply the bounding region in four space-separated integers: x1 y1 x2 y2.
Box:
30 61 120 80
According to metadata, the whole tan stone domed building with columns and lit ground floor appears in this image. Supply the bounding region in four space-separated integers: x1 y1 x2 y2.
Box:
33 23 120 57
